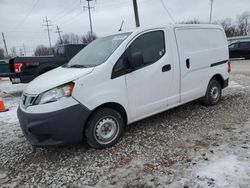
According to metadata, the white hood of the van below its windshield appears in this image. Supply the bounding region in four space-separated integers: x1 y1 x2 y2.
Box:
24 67 94 95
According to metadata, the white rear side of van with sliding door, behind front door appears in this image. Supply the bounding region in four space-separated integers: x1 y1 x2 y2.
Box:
175 28 229 103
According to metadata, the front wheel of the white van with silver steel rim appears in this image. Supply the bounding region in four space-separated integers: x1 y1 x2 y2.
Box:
85 108 124 149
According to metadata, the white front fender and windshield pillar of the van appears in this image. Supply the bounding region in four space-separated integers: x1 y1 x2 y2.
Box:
73 37 132 119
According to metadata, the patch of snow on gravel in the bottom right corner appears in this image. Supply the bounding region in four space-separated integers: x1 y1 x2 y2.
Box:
166 120 250 188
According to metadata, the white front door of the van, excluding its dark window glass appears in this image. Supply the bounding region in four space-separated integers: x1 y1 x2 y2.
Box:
125 28 173 121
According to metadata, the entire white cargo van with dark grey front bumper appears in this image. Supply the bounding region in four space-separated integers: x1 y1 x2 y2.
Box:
18 25 230 148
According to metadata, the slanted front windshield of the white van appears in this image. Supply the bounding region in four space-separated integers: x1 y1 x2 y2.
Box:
66 33 131 68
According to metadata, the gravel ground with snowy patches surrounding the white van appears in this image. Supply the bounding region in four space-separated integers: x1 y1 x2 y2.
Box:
0 61 250 188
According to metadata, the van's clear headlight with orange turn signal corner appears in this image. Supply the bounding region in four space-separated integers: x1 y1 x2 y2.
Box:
36 83 74 104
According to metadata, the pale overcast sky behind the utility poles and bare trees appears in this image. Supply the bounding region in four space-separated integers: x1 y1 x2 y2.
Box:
0 0 250 55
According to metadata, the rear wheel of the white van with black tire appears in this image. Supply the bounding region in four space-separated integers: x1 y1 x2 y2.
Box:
203 80 221 106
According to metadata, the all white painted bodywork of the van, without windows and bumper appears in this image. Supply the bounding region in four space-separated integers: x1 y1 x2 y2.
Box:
22 25 229 124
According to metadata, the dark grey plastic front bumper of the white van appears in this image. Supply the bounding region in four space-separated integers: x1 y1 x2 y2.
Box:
17 104 91 147
